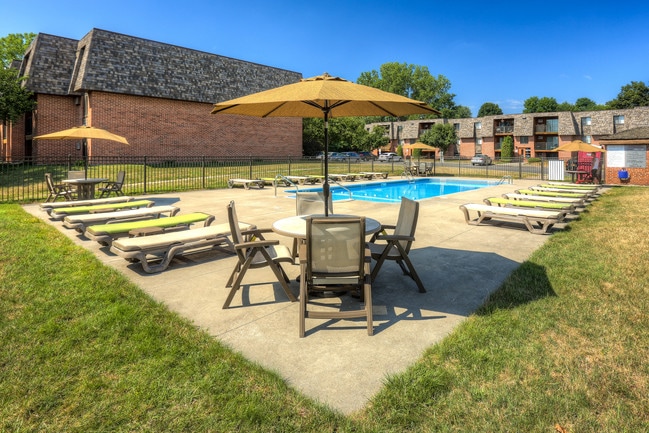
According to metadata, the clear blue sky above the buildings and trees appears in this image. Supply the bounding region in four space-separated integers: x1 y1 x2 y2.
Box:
5 0 649 116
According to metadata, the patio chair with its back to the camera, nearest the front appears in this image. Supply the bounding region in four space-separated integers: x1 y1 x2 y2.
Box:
300 216 374 337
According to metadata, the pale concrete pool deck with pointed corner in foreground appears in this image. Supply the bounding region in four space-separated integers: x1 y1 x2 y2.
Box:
25 177 561 413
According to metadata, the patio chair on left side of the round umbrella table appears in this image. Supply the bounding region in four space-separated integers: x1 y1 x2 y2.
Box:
223 201 297 309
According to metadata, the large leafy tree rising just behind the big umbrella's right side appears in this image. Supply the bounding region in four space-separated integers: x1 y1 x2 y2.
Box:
356 62 456 118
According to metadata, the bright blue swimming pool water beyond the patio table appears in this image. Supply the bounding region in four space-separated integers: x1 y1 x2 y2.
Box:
294 178 498 203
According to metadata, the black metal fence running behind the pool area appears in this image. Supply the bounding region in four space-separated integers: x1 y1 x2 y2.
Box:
0 156 548 203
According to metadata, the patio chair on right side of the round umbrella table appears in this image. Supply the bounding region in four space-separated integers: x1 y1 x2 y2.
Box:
369 197 426 293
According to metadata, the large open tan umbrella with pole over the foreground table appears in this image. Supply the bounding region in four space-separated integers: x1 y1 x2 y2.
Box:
212 73 440 215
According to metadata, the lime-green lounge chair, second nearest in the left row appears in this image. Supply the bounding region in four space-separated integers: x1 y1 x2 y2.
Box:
85 212 214 245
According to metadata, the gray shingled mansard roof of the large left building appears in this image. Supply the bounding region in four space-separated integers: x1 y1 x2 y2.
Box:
20 29 302 103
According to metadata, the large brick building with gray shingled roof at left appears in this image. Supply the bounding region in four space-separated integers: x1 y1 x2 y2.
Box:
0 29 302 161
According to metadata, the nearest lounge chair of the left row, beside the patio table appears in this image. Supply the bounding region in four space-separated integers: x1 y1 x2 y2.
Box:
110 222 255 274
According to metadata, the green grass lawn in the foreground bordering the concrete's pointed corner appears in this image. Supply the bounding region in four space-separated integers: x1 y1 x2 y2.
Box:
0 187 649 433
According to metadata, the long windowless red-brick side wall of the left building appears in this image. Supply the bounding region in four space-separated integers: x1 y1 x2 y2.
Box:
84 92 302 157
